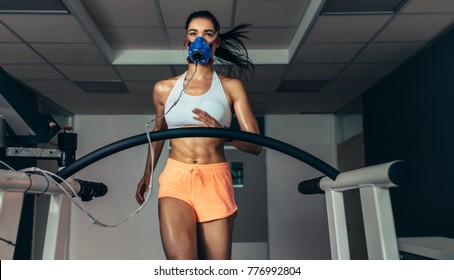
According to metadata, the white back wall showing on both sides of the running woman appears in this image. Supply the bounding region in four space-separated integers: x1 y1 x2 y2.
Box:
68 115 336 259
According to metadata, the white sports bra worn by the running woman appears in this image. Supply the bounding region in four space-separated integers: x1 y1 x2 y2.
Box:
164 72 232 128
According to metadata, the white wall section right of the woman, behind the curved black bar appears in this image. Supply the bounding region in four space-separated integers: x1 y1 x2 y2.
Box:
266 115 336 260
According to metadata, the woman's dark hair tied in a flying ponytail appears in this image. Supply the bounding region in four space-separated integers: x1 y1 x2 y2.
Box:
185 11 255 77
